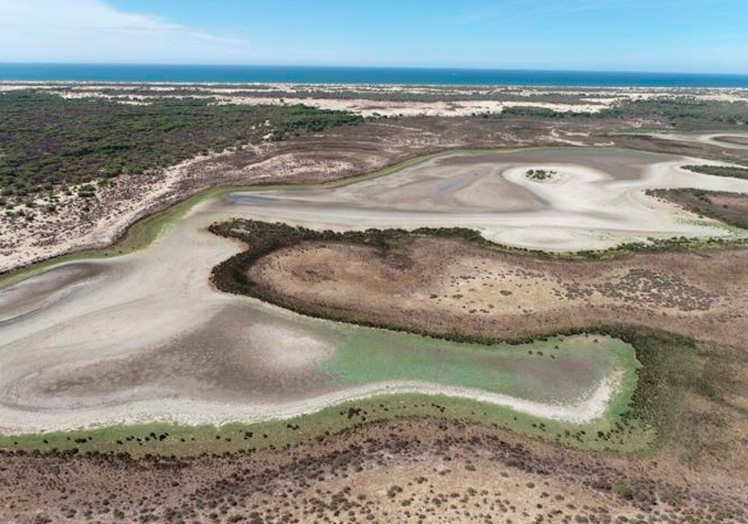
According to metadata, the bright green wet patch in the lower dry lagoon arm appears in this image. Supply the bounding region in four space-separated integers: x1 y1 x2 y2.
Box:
319 329 636 404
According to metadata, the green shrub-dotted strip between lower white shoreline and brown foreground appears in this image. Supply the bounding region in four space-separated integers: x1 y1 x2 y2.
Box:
0 391 654 456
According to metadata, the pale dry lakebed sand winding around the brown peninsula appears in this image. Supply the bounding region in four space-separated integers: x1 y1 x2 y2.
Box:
0 150 748 433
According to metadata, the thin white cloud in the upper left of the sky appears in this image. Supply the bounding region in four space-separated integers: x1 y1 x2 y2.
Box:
0 0 254 63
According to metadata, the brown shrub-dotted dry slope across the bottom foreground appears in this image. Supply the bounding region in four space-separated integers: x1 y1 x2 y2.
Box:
0 421 748 524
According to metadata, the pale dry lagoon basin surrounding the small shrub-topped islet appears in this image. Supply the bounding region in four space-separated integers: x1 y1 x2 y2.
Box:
226 148 748 251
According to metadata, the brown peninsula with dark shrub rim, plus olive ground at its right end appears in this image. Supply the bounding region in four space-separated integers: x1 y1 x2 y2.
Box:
212 221 748 492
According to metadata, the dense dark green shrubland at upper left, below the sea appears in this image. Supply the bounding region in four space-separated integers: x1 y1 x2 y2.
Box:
0 90 363 197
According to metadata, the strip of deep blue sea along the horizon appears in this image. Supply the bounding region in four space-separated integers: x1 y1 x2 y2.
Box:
0 63 748 88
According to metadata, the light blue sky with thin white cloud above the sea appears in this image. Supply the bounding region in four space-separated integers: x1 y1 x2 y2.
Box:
0 0 748 74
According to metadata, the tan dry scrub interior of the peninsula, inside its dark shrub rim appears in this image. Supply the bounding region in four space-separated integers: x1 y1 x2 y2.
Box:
247 236 748 345
